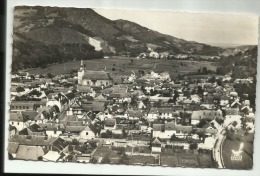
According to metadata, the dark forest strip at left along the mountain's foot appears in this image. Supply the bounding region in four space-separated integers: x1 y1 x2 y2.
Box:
12 36 104 71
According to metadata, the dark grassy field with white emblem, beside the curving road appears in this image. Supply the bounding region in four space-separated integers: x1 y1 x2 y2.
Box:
222 138 253 169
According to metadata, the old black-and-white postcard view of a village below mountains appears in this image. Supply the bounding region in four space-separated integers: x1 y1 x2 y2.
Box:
6 6 259 170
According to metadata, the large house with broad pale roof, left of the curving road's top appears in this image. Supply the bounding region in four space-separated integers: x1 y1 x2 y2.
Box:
191 110 222 125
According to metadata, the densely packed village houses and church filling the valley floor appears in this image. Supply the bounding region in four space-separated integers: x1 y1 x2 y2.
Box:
8 58 255 168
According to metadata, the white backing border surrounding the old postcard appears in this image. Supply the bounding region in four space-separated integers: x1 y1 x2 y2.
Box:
4 0 260 176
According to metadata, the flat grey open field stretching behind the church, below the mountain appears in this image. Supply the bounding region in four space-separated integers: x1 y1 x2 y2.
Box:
27 57 217 77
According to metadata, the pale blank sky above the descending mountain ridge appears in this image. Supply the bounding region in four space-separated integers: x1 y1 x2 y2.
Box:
94 9 259 45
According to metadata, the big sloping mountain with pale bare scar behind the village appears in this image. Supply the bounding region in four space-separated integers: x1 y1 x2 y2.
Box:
12 6 223 70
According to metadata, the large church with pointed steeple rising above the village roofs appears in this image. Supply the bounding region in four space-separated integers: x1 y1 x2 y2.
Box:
78 60 113 86
